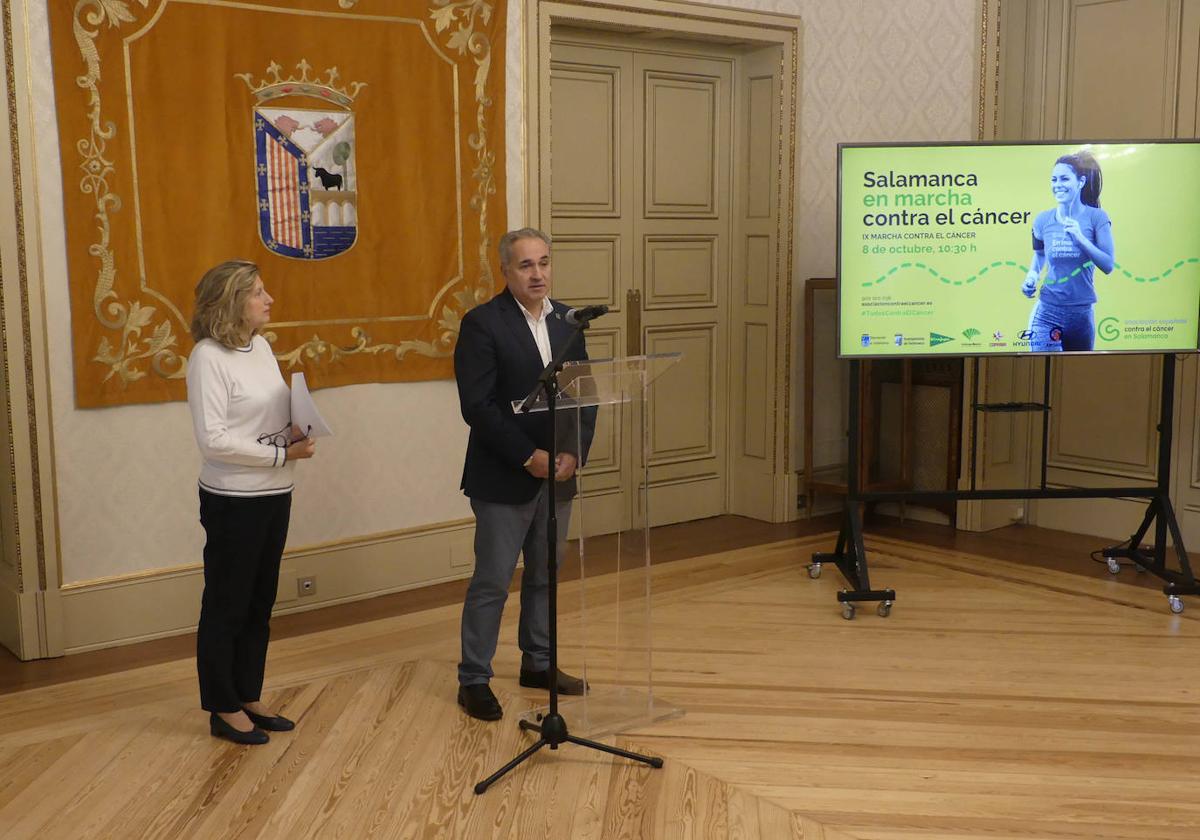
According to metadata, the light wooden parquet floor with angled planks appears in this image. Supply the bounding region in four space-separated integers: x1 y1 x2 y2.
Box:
0 535 1200 840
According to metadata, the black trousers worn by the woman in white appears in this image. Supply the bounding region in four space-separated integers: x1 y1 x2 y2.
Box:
196 488 292 712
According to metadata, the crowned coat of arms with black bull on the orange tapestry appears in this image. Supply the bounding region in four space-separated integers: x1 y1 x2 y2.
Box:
238 61 365 259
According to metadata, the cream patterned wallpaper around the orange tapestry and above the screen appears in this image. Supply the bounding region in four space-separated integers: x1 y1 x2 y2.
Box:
21 0 979 583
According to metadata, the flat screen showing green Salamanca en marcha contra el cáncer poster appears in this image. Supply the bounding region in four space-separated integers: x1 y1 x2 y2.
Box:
838 140 1200 358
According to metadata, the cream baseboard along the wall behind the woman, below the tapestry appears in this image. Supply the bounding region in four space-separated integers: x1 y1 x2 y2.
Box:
62 520 475 654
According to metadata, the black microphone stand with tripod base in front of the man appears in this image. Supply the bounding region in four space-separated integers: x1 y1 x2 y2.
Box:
475 319 662 794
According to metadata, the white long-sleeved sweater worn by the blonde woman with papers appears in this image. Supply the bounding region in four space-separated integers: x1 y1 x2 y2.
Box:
187 336 292 496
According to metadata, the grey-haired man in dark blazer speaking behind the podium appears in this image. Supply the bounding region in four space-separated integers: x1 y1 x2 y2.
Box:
454 228 595 720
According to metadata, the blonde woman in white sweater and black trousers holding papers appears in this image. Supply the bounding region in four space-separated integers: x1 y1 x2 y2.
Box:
187 260 314 744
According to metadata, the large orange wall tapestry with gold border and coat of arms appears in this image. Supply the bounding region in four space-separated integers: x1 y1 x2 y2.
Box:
50 0 505 407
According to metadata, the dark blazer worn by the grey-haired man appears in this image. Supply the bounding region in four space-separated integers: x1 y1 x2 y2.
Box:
454 289 595 504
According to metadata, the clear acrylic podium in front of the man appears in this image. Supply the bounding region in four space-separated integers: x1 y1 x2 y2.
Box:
514 353 683 738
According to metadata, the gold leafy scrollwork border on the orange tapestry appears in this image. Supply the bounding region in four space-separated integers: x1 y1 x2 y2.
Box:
60 0 501 404
